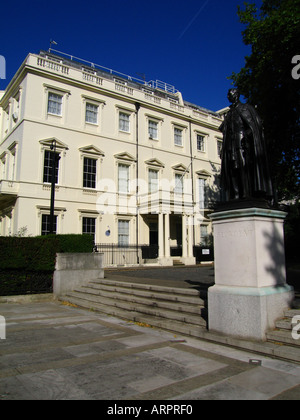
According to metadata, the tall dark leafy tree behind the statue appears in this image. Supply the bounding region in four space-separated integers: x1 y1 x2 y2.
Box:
230 0 300 200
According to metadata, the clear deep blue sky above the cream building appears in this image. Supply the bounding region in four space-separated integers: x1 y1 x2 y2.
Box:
0 0 262 111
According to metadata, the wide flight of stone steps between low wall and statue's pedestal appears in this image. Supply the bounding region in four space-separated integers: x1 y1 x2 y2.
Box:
60 279 207 337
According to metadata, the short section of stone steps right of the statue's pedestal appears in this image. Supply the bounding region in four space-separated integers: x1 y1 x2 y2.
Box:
267 309 300 350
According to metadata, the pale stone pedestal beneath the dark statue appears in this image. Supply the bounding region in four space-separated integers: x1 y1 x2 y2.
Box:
208 208 294 341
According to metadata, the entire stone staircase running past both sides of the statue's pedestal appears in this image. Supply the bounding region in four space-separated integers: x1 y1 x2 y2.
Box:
60 279 300 363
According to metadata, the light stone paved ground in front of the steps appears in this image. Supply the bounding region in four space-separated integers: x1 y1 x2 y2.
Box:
0 301 300 402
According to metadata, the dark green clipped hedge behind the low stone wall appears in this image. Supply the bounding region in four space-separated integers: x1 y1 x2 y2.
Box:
0 235 94 296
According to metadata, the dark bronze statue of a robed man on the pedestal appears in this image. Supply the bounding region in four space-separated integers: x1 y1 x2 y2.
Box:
220 89 273 202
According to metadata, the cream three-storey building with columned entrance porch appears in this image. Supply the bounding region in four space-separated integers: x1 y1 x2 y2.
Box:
0 50 222 265
